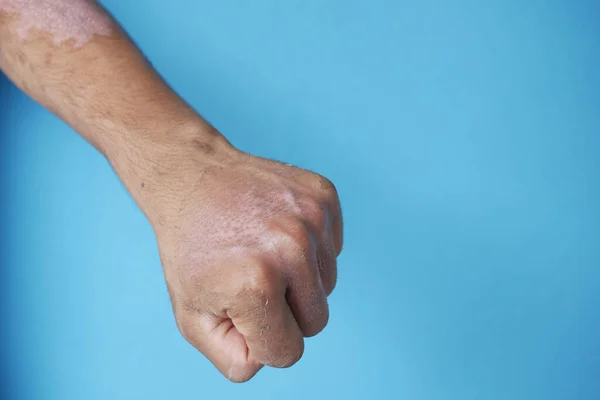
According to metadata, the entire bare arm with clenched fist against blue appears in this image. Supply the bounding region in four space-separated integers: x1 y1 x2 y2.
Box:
0 0 342 382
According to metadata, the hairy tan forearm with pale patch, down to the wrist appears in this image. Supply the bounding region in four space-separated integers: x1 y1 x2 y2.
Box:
0 0 231 219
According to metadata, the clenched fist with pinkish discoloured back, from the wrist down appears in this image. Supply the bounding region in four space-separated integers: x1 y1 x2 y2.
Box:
142 137 342 382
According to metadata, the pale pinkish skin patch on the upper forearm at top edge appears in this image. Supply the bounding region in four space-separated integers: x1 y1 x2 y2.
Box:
0 0 114 48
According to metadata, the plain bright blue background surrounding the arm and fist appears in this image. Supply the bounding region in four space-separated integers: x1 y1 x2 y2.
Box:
0 0 600 400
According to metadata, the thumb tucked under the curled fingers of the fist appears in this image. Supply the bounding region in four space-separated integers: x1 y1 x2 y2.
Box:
178 312 263 383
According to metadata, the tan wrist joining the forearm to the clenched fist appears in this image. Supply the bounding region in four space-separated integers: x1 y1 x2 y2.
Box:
105 116 238 223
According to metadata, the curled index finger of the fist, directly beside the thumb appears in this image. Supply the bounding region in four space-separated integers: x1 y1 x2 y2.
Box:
227 268 304 368
